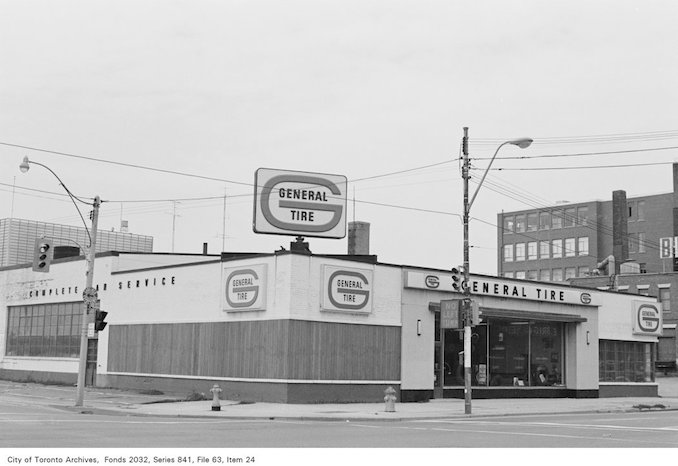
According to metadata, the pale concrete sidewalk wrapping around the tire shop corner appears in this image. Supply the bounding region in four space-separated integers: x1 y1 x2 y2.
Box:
5 378 678 421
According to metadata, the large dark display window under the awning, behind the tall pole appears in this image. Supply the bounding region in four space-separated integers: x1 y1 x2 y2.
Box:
443 318 565 387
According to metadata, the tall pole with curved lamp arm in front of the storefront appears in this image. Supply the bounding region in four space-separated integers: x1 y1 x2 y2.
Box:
462 127 532 414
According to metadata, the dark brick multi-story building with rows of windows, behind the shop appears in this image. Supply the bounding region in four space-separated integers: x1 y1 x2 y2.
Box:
497 164 678 282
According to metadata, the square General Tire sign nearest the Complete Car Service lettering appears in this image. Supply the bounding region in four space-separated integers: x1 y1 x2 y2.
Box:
223 264 266 312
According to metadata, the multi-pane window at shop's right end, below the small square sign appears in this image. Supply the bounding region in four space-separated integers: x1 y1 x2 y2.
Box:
598 340 654 382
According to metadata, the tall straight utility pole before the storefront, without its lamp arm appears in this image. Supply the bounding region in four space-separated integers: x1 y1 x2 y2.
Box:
461 127 472 414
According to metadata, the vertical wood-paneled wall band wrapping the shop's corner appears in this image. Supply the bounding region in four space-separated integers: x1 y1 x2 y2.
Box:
108 320 401 380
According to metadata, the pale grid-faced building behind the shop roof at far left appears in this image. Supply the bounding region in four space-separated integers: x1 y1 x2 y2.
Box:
0 218 153 267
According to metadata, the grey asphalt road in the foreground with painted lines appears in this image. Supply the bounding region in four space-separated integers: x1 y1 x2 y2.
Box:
0 402 678 450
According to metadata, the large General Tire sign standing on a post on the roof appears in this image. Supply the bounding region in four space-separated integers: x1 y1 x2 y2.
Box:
253 168 347 238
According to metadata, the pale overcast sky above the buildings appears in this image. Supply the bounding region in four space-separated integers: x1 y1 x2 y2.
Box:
0 0 678 274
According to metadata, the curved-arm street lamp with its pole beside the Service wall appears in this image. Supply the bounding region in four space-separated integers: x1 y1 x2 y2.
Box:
19 157 101 406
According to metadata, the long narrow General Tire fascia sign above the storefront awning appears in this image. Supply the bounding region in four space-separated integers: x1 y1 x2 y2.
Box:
405 270 600 306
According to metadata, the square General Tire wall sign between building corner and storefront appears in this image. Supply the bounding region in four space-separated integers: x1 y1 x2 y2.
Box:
321 265 373 314
